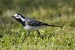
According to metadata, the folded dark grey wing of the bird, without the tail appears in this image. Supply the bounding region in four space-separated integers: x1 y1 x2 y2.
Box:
26 18 48 26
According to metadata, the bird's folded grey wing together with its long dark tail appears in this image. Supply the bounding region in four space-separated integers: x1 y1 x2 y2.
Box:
25 18 62 27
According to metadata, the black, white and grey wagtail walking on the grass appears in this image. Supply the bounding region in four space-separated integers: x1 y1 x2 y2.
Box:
12 14 61 35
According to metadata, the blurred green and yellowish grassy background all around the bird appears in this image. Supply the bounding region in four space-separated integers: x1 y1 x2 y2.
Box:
0 0 75 50
